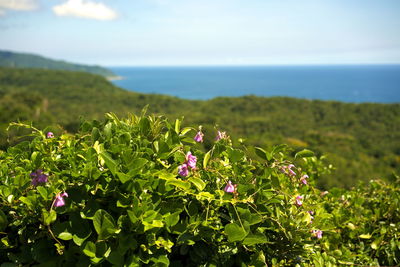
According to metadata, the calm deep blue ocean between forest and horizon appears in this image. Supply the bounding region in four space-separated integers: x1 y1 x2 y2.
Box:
109 65 400 103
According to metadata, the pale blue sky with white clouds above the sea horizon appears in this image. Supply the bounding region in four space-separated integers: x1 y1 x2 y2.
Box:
0 0 400 66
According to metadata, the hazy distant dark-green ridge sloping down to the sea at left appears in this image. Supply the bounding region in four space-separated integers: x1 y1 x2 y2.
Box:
0 51 115 77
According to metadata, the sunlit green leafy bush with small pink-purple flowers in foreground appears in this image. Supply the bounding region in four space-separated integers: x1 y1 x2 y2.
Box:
0 114 400 266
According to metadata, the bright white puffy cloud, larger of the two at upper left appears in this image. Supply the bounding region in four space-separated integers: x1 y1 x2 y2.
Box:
52 0 117 20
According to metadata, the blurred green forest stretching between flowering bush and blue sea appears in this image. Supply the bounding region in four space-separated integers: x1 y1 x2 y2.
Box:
0 68 400 188
